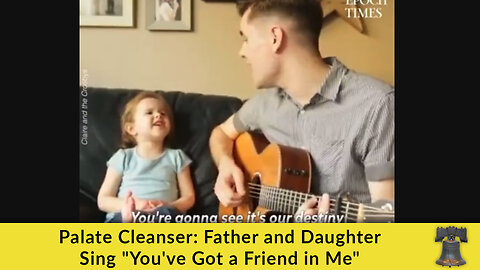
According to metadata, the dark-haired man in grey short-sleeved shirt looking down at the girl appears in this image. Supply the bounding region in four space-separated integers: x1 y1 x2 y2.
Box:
210 0 394 218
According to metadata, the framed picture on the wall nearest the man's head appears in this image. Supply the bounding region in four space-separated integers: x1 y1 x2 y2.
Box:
146 0 192 31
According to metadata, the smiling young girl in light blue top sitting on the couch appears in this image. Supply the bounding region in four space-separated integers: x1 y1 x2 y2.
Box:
98 92 195 222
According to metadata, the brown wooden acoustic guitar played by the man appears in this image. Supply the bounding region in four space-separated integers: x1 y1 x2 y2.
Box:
219 132 395 222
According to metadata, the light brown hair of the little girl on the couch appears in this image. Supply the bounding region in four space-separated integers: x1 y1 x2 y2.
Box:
121 91 175 148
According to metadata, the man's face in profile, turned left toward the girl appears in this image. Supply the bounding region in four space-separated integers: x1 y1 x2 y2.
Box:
239 9 279 88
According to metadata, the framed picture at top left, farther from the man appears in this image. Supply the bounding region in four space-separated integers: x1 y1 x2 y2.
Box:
80 0 134 27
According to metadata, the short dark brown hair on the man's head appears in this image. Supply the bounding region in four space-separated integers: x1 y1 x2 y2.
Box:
237 0 323 48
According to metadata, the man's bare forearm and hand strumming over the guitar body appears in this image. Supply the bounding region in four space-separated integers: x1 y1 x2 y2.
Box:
210 115 246 207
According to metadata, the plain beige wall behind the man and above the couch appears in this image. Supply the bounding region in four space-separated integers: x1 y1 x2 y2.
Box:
80 0 394 98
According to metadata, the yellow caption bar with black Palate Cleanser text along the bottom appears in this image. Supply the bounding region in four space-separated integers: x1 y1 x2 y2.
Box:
0 223 480 270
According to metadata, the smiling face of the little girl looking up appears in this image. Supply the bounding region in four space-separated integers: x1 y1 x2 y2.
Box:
126 98 171 143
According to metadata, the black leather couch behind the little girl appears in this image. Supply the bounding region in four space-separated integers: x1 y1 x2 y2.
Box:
79 86 242 222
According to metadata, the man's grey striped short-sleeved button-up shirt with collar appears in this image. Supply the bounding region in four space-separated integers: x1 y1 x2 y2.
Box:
233 58 394 202
